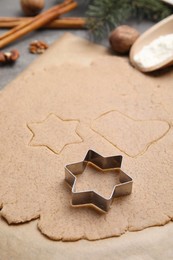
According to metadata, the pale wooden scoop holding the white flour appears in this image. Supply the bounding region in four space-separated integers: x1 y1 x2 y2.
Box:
130 15 173 72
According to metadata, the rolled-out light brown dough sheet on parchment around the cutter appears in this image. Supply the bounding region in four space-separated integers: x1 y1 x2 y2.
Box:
0 33 173 241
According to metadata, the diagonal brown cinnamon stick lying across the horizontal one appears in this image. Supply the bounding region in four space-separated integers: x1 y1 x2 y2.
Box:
0 0 77 48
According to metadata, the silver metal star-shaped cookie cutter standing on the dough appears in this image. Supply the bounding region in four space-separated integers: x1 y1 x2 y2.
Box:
65 150 133 212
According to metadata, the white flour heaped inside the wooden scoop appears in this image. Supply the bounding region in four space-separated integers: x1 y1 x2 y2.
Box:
134 34 173 68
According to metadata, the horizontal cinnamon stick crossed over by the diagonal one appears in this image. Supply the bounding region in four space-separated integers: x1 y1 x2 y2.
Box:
0 17 86 29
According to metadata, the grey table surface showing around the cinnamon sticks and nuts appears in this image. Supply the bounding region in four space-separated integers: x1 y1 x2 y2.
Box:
0 0 152 89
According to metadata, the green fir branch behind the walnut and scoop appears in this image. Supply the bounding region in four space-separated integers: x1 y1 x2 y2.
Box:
86 0 172 38
